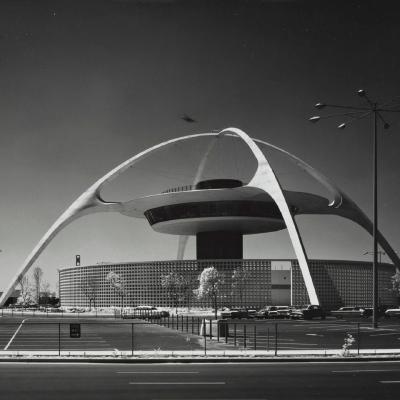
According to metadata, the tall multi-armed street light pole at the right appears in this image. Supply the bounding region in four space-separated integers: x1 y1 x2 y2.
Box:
309 89 400 328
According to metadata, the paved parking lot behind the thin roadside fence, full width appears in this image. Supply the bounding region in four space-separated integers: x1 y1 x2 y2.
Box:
0 317 400 351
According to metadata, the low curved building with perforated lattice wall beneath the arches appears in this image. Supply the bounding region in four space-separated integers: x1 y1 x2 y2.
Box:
59 259 396 310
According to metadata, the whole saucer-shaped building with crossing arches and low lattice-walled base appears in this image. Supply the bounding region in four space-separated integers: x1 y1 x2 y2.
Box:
0 128 400 307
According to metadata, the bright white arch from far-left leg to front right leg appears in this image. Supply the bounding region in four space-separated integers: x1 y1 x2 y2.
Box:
0 128 319 306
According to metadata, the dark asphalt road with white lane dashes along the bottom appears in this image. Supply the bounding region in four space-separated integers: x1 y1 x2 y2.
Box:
0 362 400 400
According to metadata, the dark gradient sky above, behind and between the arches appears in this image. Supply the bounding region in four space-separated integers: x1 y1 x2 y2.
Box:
0 0 400 290
